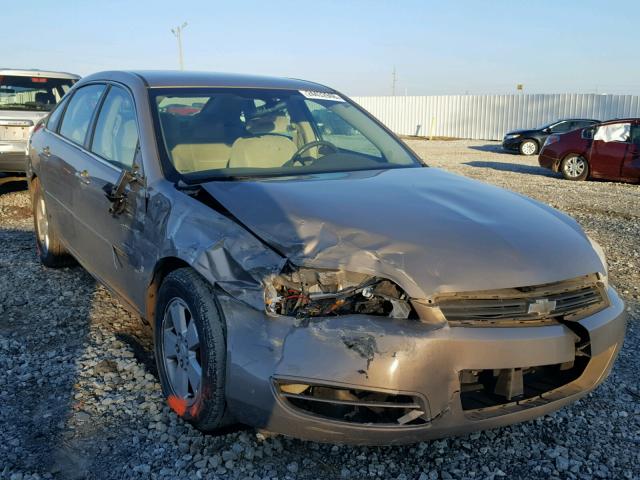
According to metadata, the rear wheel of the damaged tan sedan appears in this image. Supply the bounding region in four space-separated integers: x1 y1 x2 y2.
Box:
31 177 73 268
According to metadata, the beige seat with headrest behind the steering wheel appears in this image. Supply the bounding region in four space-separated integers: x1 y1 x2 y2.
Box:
229 115 298 168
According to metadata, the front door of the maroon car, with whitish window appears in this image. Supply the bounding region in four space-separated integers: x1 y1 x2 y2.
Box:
589 122 631 178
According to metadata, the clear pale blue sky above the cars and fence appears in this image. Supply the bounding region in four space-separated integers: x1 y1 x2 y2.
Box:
5 0 640 96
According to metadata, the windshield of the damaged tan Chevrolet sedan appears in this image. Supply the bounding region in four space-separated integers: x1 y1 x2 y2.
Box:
151 88 422 179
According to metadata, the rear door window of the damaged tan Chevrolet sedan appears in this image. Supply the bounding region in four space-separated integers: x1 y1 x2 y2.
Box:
60 85 106 145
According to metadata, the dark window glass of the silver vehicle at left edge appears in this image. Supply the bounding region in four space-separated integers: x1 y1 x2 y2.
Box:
0 75 75 112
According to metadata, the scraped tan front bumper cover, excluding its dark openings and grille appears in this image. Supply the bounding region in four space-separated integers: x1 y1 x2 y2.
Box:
220 288 626 445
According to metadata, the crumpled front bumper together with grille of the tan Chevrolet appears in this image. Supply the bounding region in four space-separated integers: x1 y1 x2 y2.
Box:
223 268 625 444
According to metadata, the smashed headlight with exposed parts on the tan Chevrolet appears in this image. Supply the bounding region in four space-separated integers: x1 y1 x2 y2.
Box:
264 268 415 318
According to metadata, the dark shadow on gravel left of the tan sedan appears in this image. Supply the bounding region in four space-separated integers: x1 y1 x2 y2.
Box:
0 225 95 479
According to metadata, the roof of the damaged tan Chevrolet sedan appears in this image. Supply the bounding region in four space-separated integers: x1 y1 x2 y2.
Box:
84 70 334 92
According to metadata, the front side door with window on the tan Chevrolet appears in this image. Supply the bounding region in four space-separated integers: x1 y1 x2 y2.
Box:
76 85 146 305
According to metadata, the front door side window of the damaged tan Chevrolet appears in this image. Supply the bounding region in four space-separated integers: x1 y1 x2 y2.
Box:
91 87 138 169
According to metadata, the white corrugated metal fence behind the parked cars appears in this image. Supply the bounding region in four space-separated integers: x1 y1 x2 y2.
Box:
353 94 640 140
